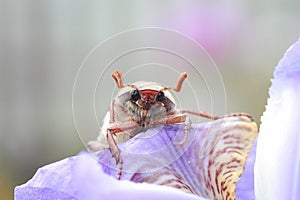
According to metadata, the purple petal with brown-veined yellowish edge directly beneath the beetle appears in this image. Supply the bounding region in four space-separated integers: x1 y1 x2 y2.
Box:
98 117 257 199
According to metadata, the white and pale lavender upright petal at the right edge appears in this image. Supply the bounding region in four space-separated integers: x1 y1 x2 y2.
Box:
255 36 300 200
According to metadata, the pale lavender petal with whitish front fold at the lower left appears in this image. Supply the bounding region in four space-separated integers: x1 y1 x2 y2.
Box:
15 154 201 200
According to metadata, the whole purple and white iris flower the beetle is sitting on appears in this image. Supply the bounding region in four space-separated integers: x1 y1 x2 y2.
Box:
15 38 300 200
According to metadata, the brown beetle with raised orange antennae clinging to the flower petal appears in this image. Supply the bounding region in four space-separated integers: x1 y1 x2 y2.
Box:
88 70 253 179
